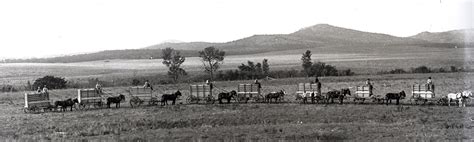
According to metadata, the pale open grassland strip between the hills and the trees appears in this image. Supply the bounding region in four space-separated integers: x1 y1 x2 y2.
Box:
0 47 474 86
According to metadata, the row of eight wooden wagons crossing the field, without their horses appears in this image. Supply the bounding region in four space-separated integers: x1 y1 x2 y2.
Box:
24 83 435 112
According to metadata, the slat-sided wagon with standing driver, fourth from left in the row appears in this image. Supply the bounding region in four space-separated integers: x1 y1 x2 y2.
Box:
186 84 216 104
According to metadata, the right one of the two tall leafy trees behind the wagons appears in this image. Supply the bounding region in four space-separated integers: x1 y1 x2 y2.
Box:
199 46 225 81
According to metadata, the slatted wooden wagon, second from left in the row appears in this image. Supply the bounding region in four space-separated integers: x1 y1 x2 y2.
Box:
77 89 104 110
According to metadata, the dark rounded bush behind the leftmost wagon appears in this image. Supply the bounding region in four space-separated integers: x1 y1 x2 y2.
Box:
33 76 67 89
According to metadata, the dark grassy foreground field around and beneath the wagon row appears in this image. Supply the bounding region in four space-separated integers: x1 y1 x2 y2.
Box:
0 73 474 141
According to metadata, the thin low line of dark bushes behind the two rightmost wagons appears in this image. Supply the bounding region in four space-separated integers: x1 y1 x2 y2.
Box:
377 66 464 74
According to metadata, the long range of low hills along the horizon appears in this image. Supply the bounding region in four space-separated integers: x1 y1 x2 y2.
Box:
6 24 468 63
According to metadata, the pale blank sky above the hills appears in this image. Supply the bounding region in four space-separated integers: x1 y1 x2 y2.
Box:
0 0 474 59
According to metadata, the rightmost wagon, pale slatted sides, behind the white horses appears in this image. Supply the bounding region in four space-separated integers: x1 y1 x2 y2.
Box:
411 84 438 104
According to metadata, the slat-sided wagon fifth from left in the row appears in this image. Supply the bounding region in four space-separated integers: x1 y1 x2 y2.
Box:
236 84 264 103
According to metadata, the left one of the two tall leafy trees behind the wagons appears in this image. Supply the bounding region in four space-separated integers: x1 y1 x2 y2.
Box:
161 47 187 82
